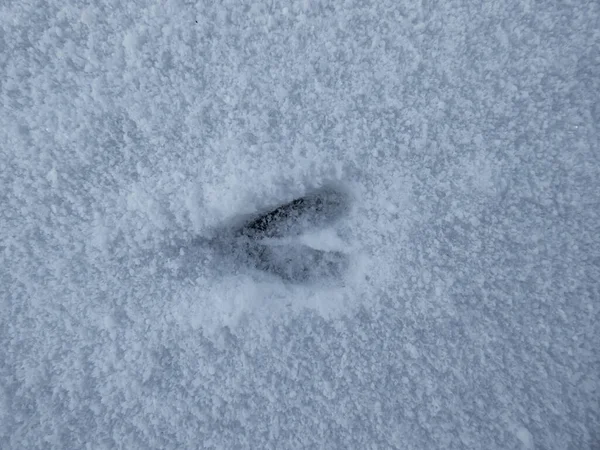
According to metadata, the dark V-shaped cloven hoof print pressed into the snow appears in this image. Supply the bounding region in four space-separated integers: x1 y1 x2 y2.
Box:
196 186 350 282
